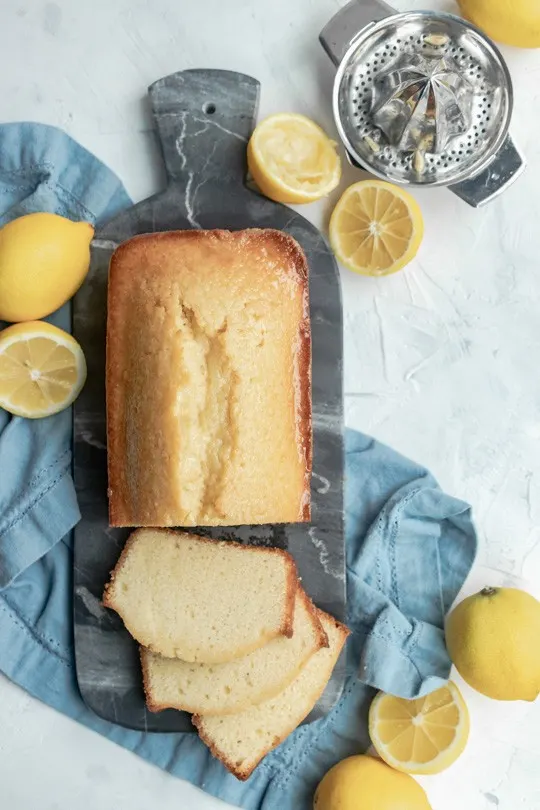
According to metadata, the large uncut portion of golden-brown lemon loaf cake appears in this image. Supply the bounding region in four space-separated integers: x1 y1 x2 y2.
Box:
106 229 312 527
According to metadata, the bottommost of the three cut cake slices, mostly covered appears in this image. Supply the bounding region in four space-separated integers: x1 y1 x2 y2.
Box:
193 611 349 780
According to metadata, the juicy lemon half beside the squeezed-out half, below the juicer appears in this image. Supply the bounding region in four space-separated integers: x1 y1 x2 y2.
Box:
330 180 424 276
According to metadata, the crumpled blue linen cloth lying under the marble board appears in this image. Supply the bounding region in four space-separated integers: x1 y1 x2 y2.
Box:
0 124 476 810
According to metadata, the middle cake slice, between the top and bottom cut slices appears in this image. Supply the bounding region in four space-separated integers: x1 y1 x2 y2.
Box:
141 587 328 714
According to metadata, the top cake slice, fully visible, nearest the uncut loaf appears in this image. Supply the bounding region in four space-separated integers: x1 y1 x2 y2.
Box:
103 529 298 664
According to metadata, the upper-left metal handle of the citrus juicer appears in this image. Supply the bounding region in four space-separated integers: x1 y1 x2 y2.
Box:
319 0 397 65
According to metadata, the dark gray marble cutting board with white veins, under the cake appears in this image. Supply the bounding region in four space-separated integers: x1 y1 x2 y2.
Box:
73 70 345 732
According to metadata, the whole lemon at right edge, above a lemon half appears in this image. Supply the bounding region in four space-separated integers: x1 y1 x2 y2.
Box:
446 588 540 700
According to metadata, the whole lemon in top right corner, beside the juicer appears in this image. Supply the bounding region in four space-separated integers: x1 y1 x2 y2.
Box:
458 0 540 48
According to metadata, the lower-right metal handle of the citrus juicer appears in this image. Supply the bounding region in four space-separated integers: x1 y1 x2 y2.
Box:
449 135 526 208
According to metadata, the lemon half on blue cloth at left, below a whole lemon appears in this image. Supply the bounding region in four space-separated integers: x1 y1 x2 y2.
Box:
0 321 86 419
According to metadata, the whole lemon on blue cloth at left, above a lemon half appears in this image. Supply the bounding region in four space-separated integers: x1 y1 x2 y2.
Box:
0 213 94 321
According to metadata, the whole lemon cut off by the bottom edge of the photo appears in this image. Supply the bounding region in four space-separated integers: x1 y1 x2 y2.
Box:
313 756 431 810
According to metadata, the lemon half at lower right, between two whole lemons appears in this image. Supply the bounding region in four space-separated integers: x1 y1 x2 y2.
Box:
369 682 469 774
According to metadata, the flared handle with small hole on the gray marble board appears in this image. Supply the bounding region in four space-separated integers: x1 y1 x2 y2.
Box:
148 69 260 186
